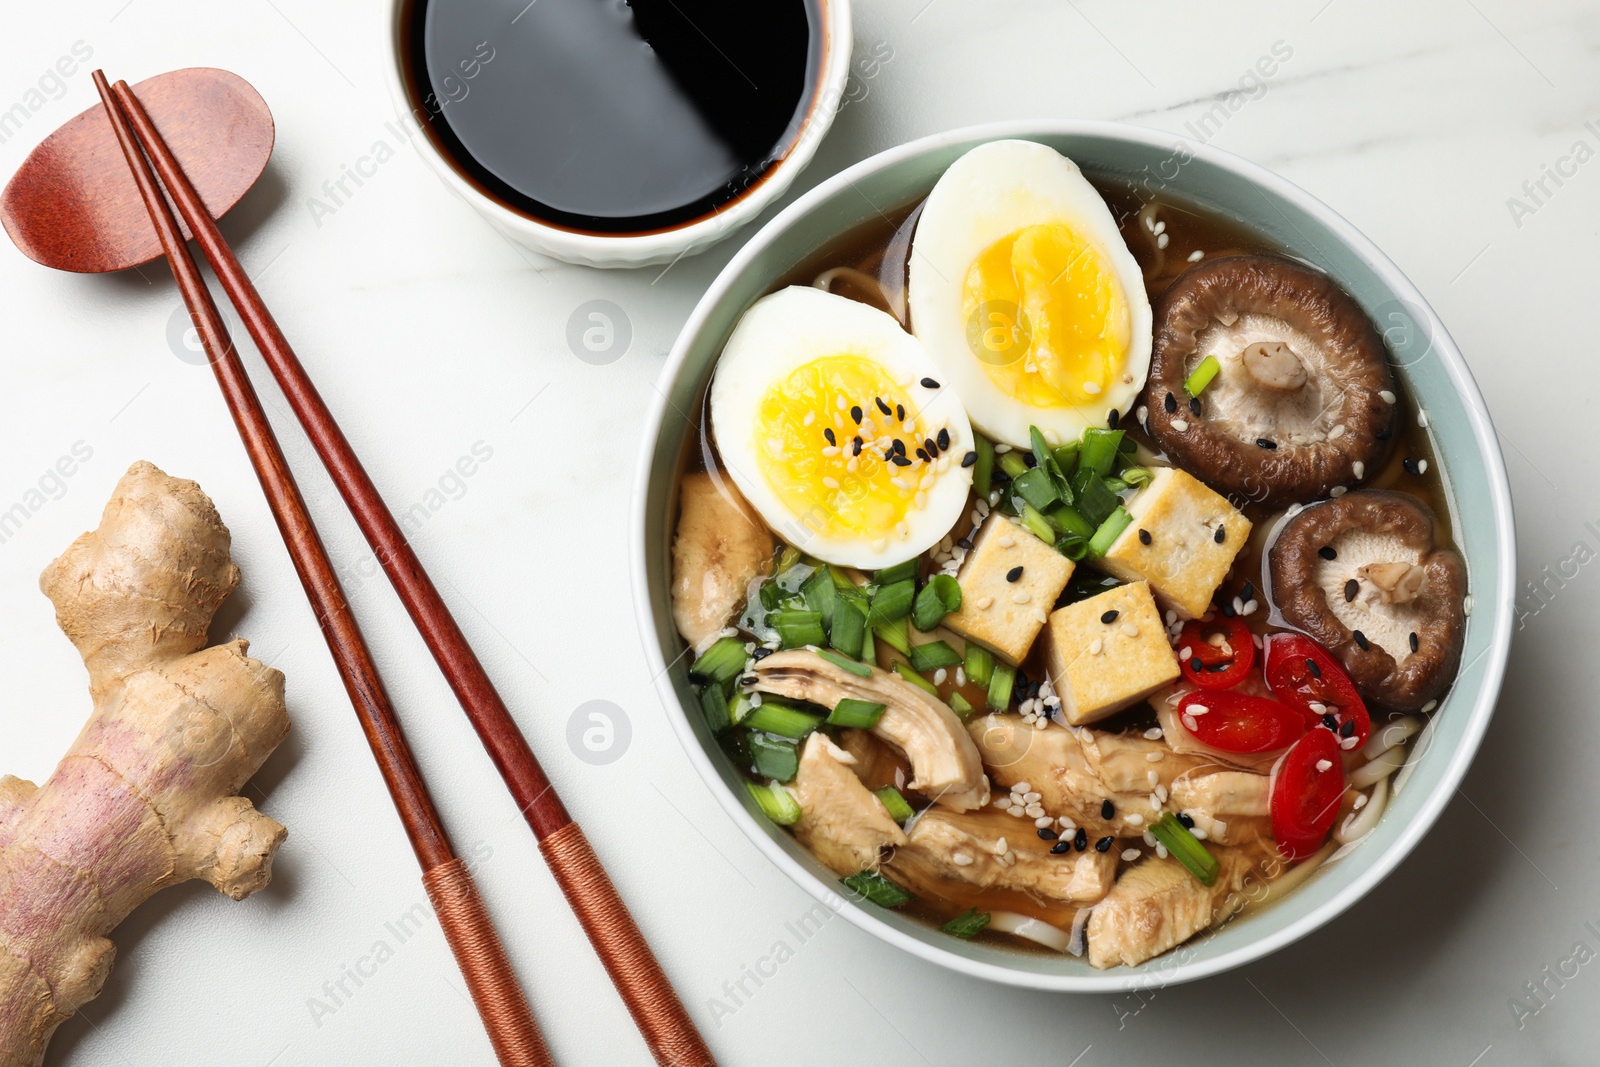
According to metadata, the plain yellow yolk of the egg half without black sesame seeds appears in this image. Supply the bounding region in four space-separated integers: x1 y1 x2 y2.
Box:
962 222 1133 408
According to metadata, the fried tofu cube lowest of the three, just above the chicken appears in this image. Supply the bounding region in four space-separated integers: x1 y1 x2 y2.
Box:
1045 582 1179 726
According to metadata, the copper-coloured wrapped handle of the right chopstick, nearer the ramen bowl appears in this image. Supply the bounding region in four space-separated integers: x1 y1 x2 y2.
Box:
539 822 717 1067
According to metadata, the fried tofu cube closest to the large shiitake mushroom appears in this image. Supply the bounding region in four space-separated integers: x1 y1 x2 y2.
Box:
1101 467 1250 619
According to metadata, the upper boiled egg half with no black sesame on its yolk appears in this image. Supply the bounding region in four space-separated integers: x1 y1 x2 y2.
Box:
909 141 1150 446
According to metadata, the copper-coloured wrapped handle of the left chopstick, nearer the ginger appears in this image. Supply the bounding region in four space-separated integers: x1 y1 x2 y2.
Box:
422 859 554 1067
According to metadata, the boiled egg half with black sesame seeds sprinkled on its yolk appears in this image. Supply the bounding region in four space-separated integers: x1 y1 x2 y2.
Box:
710 286 973 569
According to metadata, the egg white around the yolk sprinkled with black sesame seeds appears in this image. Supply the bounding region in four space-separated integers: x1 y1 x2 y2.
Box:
710 285 973 569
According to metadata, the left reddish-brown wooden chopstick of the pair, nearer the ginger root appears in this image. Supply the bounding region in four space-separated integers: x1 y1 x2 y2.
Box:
93 70 554 1067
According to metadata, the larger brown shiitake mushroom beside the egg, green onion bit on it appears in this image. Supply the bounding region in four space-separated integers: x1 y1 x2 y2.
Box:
1144 254 1397 506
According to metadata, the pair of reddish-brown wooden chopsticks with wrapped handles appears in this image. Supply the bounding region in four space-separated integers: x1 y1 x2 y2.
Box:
94 70 714 1067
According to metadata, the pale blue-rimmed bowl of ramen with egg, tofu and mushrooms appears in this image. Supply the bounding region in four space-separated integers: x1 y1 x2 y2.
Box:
634 122 1514 990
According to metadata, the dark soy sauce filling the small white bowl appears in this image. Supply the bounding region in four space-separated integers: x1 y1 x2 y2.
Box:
403 0 822 234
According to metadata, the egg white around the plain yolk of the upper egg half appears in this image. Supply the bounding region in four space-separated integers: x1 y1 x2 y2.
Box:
909 141 1150 448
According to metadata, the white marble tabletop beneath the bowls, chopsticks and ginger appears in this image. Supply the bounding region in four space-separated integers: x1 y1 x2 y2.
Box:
0 0 1600 1067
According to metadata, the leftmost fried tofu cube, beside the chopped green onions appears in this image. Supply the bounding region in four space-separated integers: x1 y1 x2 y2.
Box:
944 512 1072 667
